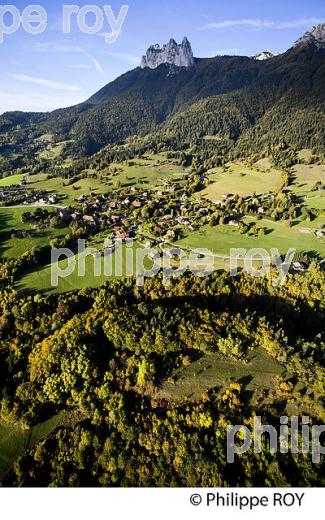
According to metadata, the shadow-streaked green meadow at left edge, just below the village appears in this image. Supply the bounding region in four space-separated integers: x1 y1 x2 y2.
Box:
0 207 67 258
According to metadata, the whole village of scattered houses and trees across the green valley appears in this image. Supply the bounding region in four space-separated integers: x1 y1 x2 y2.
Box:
0 173 325 271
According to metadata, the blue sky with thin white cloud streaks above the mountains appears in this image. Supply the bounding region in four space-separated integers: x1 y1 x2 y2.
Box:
0 0 325 113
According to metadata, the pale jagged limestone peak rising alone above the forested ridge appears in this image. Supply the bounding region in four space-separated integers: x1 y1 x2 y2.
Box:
141 38 194 69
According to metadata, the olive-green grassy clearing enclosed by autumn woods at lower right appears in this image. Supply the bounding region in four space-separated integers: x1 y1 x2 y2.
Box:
154 347 324 416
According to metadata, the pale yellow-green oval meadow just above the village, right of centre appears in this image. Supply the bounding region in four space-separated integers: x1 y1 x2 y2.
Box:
200 163 281 202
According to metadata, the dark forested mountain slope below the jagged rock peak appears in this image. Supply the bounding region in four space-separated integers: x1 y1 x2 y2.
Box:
0 23 325 162
